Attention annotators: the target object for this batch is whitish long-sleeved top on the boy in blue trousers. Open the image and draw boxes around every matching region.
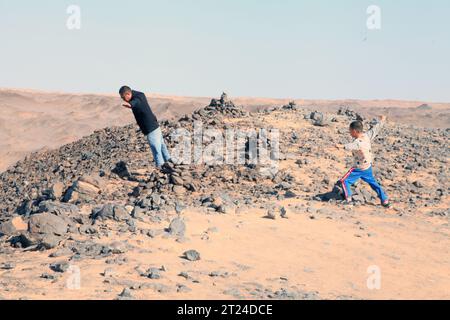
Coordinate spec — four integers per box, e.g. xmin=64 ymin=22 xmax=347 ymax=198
xmin=344 ymin=121 xmax=384 ymax=170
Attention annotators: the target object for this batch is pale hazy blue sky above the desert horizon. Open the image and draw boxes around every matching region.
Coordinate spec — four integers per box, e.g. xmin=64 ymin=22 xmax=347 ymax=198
xmin=0 ymin=0 xmax=450 ymax=102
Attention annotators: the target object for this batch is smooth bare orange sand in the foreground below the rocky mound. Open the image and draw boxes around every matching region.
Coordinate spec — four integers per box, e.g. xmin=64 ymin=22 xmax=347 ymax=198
xmin=0 ymin=203 xmax=450 ymax=299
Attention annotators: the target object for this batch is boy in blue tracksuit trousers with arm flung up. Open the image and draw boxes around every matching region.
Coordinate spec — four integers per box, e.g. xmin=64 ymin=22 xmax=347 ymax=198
xmin=338 ymin=116 xmax=391 ymax=208
